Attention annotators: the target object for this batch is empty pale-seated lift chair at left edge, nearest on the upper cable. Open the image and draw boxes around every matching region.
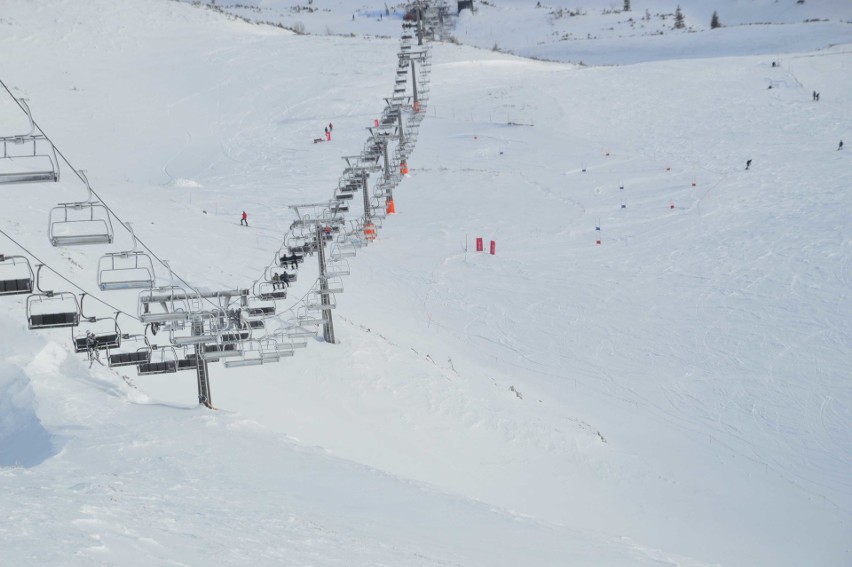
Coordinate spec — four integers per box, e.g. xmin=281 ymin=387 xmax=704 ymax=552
xmin=0 ymin=99 xmax=59 ymax=184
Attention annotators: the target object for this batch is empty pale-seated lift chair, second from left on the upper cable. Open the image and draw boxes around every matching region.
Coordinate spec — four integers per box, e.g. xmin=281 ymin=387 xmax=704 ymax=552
xmin=48 ymin=171 xmax=113 ymax=246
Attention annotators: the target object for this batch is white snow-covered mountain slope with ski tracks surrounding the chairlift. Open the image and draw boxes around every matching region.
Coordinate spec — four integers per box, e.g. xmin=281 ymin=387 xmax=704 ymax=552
xmin=0 ymin=0 xmax=852 ymax=566
